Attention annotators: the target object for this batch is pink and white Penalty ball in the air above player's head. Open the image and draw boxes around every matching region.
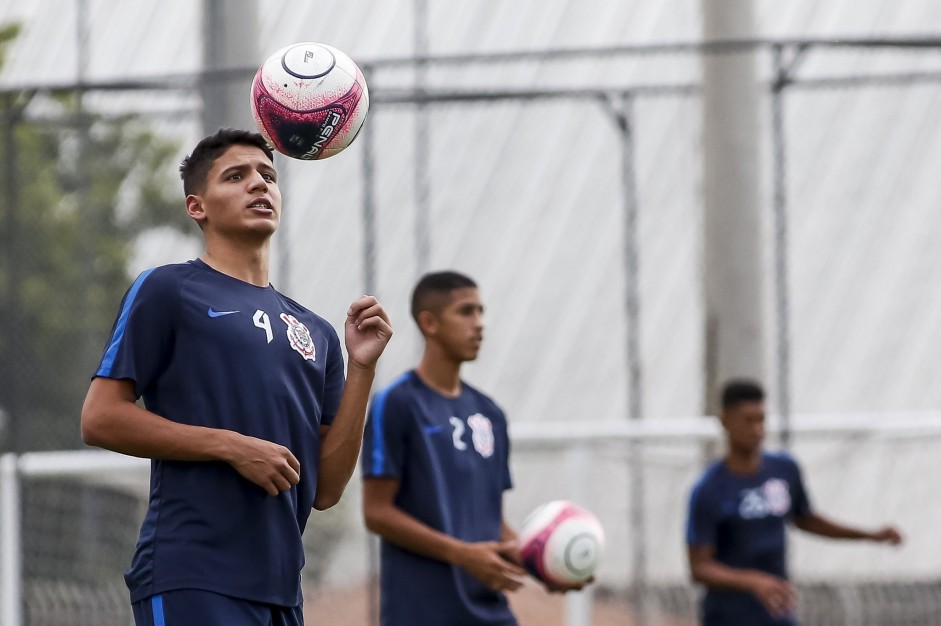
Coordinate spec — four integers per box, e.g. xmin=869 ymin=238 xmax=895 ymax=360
xmin=252 ymin=42 xmax=369 ymax=160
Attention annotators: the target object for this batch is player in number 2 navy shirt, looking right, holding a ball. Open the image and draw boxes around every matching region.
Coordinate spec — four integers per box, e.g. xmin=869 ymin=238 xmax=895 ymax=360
xmin=362 ymin=272 xmax=525 ymax=626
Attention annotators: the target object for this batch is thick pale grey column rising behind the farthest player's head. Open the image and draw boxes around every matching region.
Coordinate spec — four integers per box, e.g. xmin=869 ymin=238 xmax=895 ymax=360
xmin=700 ymin=0 xmax=765 ymax=420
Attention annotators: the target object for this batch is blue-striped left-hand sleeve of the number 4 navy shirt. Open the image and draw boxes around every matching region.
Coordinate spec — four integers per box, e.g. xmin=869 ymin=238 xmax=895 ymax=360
xmin=95 ymin=269 xmax=179 ymax=396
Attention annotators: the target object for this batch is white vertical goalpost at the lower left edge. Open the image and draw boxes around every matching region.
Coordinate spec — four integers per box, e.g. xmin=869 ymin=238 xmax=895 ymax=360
xmin=0 ymin=452 xmax=23 ymax=626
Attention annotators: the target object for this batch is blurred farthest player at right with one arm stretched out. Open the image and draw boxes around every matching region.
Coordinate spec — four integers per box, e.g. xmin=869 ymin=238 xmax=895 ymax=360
xmin=686 ymin=380 xmax=902 ymax=626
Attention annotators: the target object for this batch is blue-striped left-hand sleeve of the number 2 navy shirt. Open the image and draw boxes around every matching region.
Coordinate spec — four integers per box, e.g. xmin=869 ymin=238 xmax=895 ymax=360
xmin=360 ymin=387 xmax=408 ymax=478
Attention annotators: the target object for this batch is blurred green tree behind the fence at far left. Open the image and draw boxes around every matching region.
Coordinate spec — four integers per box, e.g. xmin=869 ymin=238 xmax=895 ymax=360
xmin=0 ymin=26 xmax=192 ymax=450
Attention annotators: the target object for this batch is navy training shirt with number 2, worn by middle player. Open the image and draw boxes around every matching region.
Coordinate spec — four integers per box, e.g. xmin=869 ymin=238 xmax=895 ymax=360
xmin=361 ymin=371 xmax=516 ymax=626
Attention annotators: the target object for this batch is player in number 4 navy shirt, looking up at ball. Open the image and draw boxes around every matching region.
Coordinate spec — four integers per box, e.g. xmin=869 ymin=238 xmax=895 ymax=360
xmin=82 ymin=129 xmax=392 ymax=626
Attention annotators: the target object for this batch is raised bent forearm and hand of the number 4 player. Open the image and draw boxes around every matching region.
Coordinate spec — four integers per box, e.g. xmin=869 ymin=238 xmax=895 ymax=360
xmin=314 ymin=296 xmax=392 ymax=511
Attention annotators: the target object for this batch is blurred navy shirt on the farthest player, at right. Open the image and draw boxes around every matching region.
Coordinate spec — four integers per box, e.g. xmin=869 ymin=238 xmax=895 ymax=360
xmin=686 ymin=452 xmax=811 ymax=626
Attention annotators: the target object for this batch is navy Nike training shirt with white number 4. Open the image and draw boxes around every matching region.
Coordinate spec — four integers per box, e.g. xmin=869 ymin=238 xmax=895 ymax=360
xmin=96 ymin=260 xmax=344 ymax=606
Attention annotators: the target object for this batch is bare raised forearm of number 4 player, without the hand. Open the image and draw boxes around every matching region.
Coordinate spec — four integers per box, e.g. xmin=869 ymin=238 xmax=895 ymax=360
xmin=314 ymin=361 xmax=376 ymax=511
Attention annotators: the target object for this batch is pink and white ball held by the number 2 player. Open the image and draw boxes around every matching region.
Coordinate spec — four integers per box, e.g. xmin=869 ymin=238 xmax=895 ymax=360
xmin=519 ymin=500 xmax=604 ymax=585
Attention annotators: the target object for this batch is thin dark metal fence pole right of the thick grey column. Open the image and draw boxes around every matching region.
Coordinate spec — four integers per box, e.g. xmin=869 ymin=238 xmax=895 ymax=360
xmin=771 ymin=45 xmax=791 ymax=448
